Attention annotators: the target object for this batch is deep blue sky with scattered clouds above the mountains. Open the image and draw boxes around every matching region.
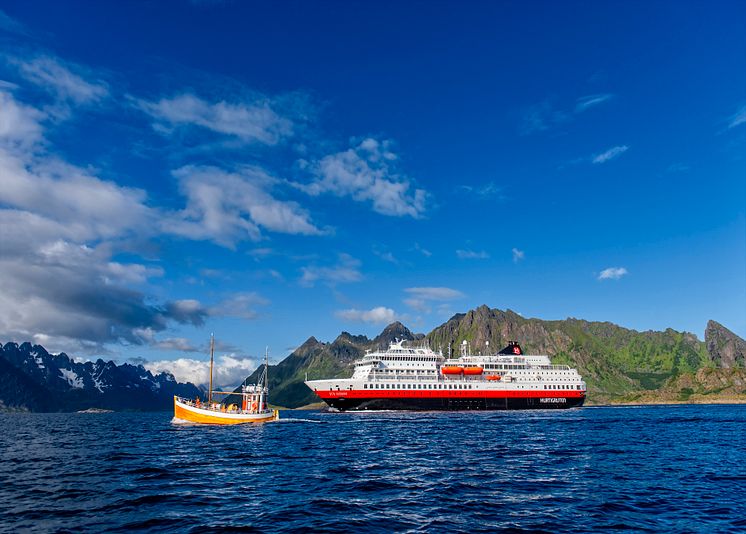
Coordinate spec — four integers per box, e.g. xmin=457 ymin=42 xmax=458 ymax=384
xmin=0 ymin=1 xmax=746 ymax=381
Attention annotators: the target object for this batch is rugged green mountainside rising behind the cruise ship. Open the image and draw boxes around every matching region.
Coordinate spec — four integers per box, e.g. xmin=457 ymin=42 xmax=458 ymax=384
xmin=235 ymin=306 xmax=746 ymax=408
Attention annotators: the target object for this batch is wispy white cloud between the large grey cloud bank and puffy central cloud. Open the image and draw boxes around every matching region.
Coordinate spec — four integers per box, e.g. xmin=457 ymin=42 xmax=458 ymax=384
xmin=162 ymin=166 xmax=323 ymax=247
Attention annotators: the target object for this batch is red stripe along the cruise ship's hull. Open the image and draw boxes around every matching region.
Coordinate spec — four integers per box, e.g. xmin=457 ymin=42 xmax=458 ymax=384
xmin=315 ymin=389 xmax=585 ymax=399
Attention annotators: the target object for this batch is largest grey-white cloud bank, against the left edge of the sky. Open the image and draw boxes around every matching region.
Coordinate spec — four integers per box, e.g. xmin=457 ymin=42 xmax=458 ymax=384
xmin=0 ymin=93 xmax=204 ymax=350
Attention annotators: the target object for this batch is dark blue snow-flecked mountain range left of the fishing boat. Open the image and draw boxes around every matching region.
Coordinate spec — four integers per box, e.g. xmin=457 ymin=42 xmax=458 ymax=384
xmin=0 ymin=343 xmax=201 ymax=412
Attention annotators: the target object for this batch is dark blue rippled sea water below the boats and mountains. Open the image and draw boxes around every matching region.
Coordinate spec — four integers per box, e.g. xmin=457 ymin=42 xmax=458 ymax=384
xmin=0 ymin=406 xmax=746 ymax=532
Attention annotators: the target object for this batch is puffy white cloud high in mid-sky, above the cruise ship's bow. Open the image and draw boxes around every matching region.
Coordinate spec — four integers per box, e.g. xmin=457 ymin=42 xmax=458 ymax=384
xmin=294 ymin=138 xmax=428 ymax=218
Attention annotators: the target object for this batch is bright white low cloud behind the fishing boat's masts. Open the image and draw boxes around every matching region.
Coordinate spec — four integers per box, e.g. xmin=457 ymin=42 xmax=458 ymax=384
xmin=144 ymin=354 xmax=256 ymax=390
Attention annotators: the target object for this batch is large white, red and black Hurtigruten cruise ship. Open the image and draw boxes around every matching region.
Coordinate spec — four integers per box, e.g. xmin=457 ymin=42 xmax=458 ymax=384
xmin=305 ymin=341 xmax=586 ymax=411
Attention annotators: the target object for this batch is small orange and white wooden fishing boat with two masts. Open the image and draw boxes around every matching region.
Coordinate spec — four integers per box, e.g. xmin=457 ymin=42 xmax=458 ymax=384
xmin=174 ymin=336 xmax=280 ymax=425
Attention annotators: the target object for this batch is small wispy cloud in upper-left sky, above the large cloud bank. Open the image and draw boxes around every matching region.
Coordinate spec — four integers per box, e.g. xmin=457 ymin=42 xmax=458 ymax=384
xmin=11 ymin=56 xmax=109 ymax=104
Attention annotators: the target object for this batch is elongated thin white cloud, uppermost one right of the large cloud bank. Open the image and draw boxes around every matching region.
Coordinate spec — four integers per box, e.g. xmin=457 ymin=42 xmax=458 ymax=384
xmin=136 ymin=93 xmax=293 ymax=145
